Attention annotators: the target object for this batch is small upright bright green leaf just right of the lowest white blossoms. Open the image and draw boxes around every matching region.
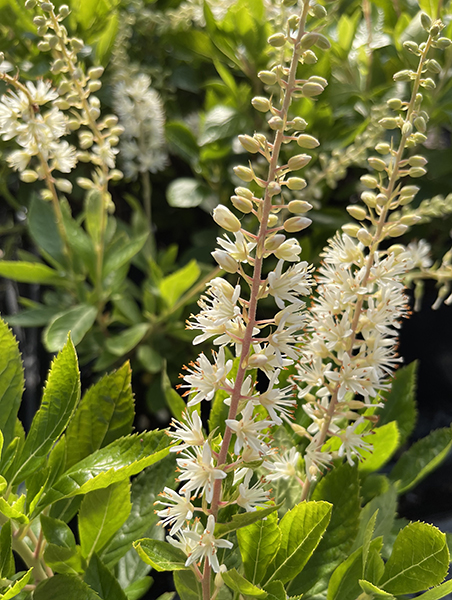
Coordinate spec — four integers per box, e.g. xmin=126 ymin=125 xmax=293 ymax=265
xmin=237 ymin=512 xmax=281 ymax=583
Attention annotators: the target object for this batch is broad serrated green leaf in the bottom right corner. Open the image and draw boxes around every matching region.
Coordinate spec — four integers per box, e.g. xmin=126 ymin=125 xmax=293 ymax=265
xmin=379 ymin=523 xmax=449 ymax=594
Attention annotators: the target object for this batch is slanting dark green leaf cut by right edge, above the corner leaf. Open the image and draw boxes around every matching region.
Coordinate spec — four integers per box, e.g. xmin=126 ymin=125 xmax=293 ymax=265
xmin=389 ymin=428 xmax=452 ymax=494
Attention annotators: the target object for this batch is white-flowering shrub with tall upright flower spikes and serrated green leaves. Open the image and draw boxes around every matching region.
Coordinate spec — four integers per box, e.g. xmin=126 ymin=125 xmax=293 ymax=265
xmin=0 ymin=0 xmax=452 ymax=600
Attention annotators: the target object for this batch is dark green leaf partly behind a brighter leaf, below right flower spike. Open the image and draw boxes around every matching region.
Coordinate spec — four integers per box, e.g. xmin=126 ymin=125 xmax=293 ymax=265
xmin=292 ymin=463 xmax=361 ymax=600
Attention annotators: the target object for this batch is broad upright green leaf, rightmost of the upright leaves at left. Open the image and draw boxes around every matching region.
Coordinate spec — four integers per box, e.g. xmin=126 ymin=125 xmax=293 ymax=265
xmin=66 ymin=362 xmax=135 ymax=468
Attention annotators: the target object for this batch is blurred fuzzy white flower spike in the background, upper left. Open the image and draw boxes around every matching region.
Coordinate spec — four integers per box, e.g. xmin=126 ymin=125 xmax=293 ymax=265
xmin=113 ymin=72 xmax=168 ymax=179
